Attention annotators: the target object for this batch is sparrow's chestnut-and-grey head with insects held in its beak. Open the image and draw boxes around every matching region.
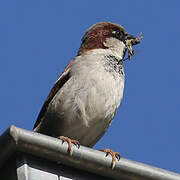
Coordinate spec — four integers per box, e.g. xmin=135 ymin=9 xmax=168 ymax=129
xmin=78 ymin=22 xmax=142 ymax=60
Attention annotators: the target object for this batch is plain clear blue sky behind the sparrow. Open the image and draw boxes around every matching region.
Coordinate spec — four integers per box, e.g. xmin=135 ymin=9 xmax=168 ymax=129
xmin=0 ymin=0 xmax=180 ymax=172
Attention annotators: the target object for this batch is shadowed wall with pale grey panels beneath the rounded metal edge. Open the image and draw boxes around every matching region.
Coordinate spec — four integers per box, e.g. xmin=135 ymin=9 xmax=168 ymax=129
xmin=17 ymin=154 xmax=109 ymax=180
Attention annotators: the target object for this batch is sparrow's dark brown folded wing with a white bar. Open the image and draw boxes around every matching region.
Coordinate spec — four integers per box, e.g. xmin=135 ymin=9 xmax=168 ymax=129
xmin=33 ymin=59 xmax=74 ymax=129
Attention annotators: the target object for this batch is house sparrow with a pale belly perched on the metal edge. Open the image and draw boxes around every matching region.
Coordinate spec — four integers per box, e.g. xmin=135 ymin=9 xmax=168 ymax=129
xmin=34 ymin=22 xmax=141 ymax=168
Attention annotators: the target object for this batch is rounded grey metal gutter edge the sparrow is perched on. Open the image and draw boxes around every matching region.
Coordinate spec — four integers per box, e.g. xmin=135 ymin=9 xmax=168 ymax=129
xmin=0 ymin=126 xmax=180 ymax=180
